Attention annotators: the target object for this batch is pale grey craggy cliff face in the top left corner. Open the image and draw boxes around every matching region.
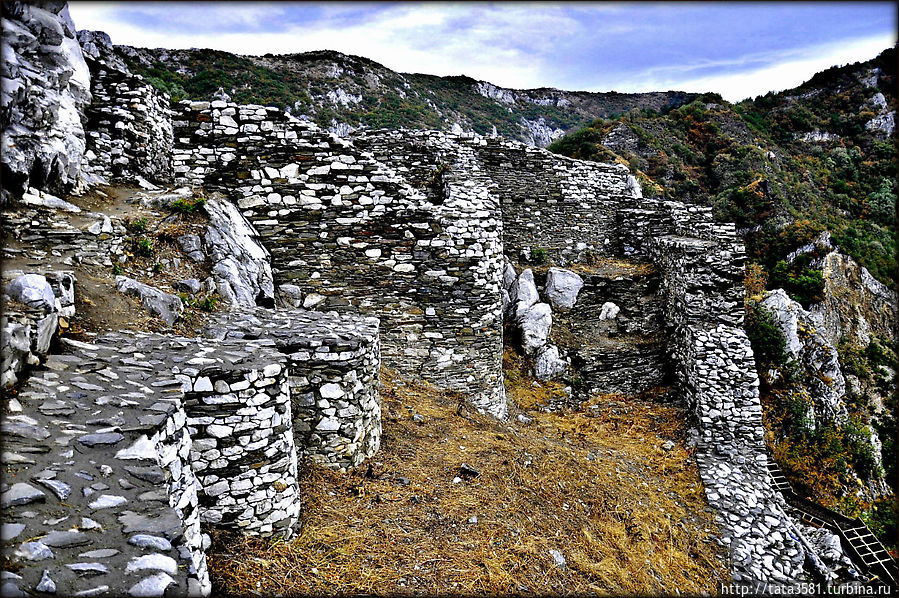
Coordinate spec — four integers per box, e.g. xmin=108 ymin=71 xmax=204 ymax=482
xmin=0 ymin=1 xmax=91 ymax=203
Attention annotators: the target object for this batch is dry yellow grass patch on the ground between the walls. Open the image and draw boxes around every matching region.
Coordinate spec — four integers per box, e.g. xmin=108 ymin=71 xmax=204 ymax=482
xmin=209 ymin=372 xmax=725 ymax=595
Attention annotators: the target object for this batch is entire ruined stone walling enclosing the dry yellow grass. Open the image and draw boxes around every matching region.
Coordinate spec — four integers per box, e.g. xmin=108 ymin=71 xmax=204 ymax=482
xmin=2 ymin=61 xmax=868 ymax=595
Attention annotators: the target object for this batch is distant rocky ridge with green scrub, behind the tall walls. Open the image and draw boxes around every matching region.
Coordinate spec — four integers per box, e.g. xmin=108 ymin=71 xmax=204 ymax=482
xmin=105 ymin=46 xmax=696 ymax=146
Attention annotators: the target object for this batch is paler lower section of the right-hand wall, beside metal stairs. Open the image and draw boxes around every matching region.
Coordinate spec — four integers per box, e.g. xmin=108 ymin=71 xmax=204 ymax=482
xmin=676 ymin=325 xmax=806 ymax=585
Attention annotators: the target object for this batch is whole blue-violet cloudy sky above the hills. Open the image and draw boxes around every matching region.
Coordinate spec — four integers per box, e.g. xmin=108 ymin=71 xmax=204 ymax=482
xmin=70 ymin=1 xmax=897 ymax=101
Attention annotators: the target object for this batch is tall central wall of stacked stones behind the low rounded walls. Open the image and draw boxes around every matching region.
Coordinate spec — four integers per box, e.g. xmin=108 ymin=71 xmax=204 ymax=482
xmin=174 ymin=101 xmax=506 ymax=417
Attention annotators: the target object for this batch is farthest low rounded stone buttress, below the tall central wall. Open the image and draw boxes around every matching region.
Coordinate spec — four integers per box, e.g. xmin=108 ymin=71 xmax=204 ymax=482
xmin=205 ymin=309 xmax=381 ymax=470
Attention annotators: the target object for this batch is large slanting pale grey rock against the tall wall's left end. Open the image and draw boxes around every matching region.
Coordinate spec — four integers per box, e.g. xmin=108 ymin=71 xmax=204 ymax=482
xmin=205 ymin=198 xmax=275 ymax=309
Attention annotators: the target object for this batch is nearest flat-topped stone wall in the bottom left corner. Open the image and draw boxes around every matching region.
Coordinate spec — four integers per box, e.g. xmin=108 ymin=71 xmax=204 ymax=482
xmin=0 ymin=339 xmax=210 ymax=596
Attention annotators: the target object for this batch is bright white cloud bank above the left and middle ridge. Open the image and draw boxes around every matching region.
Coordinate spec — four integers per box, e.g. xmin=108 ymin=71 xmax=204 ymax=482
xmin=71 ymin=2 xmax=552 ymax=87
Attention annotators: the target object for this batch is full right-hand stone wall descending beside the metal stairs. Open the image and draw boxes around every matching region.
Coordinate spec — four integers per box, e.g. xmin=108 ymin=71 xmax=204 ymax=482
xmin=644 ymin=202 xmax=808 ymax=587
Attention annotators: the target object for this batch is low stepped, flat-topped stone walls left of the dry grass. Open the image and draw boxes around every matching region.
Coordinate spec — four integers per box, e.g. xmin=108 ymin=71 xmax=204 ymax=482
xmin=2 ymin=309 xmax=380 ymax=596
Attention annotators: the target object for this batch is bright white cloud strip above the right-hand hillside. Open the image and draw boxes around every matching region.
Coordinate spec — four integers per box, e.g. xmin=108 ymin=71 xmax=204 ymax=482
xmin=608 ymin=34 xmax=896 ymax=102
